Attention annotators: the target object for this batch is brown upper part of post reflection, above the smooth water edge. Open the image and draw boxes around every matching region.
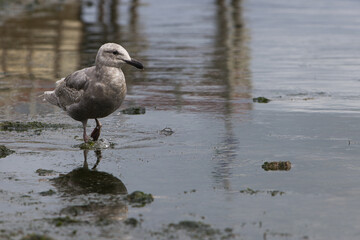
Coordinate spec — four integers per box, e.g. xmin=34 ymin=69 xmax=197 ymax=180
xmin=208 ymin=0 xmax=252 ymax=114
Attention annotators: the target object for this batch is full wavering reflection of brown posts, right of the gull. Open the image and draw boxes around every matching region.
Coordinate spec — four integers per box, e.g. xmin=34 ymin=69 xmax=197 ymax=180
xmin=212 ymin=0 xmax=252 ymax=190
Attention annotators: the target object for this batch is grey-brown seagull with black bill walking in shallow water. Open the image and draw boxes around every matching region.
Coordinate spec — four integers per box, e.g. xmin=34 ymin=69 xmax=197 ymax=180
xmin=44 ymin=43 xmax=144 ymax=142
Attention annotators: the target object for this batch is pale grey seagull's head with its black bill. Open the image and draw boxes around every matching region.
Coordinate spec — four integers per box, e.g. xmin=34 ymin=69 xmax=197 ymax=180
xmin=96 ymin=43 xmax=144 ymax=69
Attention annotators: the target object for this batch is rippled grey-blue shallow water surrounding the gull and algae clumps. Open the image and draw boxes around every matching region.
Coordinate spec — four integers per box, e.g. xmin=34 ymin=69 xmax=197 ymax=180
xmin=0 ymin=0 xmax=360 ymax=239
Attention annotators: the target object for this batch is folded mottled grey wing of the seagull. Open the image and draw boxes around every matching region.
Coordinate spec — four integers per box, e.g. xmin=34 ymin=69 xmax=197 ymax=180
xmin=44 ymin=67 xmax=95 ymax=111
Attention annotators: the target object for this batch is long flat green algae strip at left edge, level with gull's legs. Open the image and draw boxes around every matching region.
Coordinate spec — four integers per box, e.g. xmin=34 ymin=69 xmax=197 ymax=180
xmin=0 ymin=121 xmax=71 ymax=132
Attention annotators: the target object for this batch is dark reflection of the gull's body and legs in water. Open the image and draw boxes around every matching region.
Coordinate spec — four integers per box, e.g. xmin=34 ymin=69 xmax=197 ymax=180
xmin=52 ymin=150 xmax=128 ymax=222
